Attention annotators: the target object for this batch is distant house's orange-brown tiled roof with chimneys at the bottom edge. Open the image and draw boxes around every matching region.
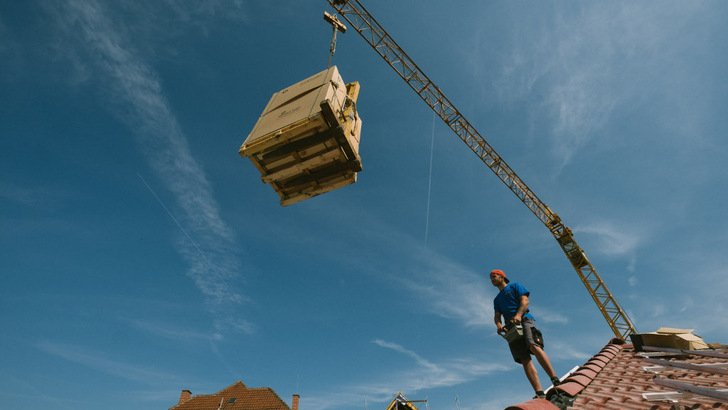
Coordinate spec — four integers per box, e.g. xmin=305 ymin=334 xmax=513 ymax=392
xmin=169 ymin=381 xmax=299 ymax=410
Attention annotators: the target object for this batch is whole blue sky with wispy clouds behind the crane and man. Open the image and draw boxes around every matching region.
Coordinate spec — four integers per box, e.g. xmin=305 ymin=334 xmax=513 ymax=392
xmin=0 ymin=0 xmax=728 ymax=409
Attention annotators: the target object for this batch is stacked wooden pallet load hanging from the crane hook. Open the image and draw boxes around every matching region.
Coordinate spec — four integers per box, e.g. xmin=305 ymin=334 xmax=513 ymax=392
xmin=238 ymin=66 xmax=362 ymax=206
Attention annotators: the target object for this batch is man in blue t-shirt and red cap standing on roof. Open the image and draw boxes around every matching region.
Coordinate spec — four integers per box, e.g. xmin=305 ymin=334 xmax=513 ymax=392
xmin=490 ymin=269 xmax=559 ymax=398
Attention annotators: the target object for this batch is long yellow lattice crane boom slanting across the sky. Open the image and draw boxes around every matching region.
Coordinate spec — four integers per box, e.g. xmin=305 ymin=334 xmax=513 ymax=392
xmin=328 ymin=0 xmax=637 ymax=340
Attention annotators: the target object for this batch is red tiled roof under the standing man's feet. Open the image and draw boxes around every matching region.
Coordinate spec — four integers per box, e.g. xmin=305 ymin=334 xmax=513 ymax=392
xmin=508 ymin=339 xmax=728 ymax=410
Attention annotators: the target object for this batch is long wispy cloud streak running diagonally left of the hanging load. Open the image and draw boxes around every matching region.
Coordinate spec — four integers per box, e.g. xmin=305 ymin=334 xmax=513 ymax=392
xmin=48 ymin=1 xmax=253 ymax=335
